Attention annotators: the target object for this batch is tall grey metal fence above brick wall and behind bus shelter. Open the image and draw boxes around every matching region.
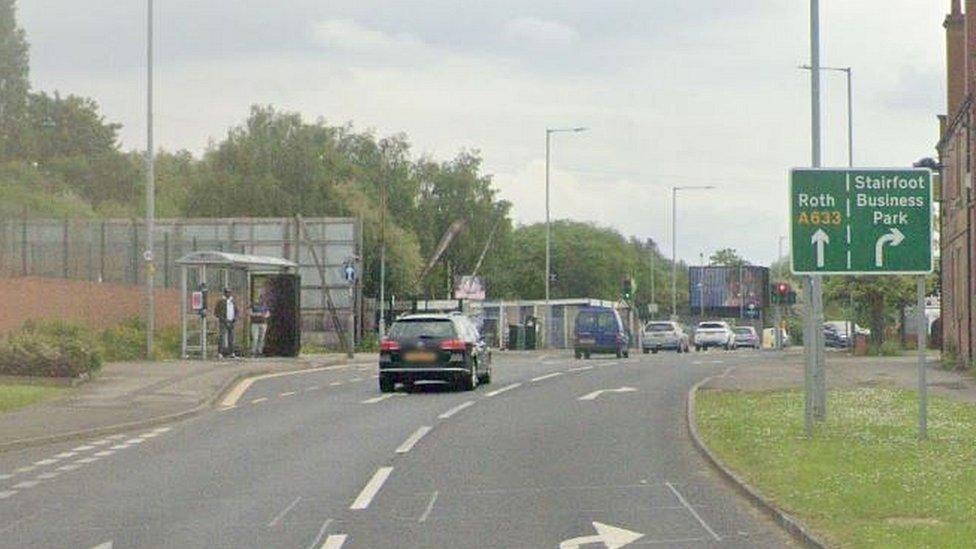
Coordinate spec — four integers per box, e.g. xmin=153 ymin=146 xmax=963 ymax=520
xmin=0 ymin=218 xmax=362 ymax=343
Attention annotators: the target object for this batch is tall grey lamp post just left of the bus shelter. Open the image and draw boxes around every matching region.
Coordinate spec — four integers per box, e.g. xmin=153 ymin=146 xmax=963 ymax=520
xmin=143 ymin=0 xmax=155 ymax=358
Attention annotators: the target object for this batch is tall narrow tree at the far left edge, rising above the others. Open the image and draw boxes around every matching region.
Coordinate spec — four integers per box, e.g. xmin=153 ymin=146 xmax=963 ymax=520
xmin=0 ymin=0 xmax=30 ymax=161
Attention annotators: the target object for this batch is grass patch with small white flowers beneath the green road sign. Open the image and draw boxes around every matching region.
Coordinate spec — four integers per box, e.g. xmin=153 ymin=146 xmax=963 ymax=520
xmin=697 ymin=388 xmax=976 ymax=548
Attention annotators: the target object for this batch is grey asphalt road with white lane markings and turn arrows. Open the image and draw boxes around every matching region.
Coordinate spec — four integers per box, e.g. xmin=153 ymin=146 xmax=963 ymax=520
xmin=0 ymin=351 xmax=791 ymax=549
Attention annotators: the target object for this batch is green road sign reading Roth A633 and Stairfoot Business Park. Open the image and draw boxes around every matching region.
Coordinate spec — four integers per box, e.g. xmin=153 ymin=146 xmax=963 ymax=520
xmin=790 ymin=169 xmax=932 ymax=274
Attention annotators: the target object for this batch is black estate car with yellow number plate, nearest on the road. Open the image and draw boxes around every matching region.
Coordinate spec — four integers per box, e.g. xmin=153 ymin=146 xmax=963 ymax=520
xmin=379 ymin=313 xmax=491 ymax=393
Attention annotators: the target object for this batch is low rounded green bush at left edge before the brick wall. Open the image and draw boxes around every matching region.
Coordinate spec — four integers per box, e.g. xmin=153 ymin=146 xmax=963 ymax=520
xmin=0 ymin=322 xmax=102 ymax=377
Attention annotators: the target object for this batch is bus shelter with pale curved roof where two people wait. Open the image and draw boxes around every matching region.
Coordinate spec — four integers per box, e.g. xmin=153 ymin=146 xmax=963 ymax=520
xmin=176 ymin=251 xmax=301 ymax=358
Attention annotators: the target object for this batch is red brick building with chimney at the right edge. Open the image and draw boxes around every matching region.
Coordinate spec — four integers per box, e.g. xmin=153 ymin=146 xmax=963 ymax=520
xmin=937 ymin=0 xmax=976 ymax=364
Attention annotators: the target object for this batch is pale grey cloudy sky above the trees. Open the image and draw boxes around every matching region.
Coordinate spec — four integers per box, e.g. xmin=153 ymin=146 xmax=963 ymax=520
xmin=19 ymin=0 xmax=949 ymax=263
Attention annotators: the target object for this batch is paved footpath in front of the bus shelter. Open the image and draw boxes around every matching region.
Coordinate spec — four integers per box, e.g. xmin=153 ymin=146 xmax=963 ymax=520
xmin=0 ymin=353 xmax=376 ymax=451
